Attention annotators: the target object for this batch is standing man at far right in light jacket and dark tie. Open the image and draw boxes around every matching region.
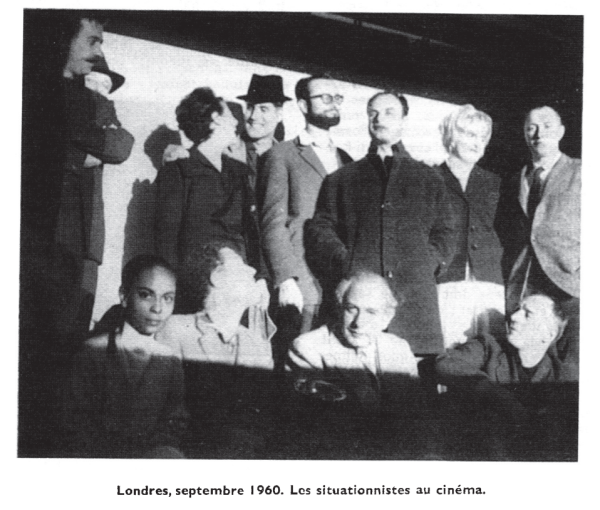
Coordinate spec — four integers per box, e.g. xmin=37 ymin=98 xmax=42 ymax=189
xmin=506 ymin=106 xmax=581 ymax=315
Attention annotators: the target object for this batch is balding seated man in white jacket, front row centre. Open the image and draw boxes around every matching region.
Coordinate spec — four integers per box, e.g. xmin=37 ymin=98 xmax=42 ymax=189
xmin=288 ymin=273 xmax=418 ymax=412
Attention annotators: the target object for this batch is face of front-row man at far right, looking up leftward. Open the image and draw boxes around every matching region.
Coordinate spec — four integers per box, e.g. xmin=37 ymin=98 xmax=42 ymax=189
xmin=508 ymin=295 xmax=561 ymax=350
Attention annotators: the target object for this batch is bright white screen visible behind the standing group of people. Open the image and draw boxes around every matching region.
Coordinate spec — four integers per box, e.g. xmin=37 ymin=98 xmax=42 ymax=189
xmin=93 ymin=33 xmax=455 ymax=321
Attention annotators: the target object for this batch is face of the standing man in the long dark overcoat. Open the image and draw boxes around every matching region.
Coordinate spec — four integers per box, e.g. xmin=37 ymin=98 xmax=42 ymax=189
xmin=367 ymin=94 xmax=404 ymax=145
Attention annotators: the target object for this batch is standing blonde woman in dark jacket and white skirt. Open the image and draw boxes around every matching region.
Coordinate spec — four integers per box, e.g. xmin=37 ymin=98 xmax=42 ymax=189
xmin=438 ymin=105 xmax=504 ymax=347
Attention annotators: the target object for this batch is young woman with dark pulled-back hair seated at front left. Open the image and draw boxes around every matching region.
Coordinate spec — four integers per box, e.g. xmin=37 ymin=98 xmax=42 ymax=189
xmin=65 ymin=255 xmax=187 ymax=458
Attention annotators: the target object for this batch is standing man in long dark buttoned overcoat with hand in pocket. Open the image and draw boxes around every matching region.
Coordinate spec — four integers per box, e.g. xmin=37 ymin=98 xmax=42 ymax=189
xmin=305 ymin=92 xmax=456 ymax=355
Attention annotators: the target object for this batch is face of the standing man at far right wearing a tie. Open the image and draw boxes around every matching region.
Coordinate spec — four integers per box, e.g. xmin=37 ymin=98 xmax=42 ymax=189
xmin=524 ymin=106 xmax=565 ymax=161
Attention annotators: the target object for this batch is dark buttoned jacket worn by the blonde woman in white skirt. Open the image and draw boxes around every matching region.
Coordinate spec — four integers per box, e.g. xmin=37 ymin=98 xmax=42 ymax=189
xmin=437 ymin=163 xmax=504 ymax=285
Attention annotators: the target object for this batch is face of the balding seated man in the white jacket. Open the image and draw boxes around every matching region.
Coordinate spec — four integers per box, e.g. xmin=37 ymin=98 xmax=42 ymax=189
xmin=342 ymin=280 xmax=394 ymax=347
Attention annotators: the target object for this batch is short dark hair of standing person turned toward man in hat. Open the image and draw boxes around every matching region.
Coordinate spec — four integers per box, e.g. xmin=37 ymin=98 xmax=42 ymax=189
xmin=175 ymin=87 xmax=223 ymax=144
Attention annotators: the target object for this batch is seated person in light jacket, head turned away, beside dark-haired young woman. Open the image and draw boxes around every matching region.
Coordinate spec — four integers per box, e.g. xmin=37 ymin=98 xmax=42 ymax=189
xmin=157 ymin=242 xmax=274 ymax=458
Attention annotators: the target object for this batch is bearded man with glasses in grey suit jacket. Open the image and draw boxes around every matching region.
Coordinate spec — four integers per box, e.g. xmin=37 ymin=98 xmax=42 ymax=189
xmin=257 ymin=76 xmax=352 ymax=346
